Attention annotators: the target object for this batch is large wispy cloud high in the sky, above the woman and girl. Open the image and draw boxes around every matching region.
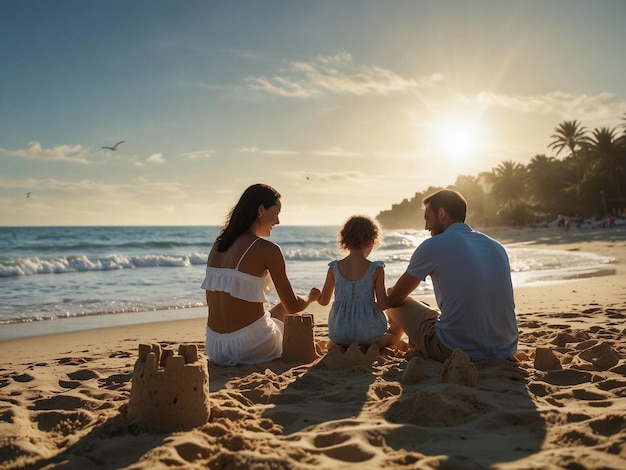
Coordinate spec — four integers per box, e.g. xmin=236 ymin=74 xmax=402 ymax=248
xmin=246 ymin=53 xmax=443 ymax=98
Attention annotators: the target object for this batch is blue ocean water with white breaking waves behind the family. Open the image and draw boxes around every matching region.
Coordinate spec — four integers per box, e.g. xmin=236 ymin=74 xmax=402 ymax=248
xmin=0 ymin=226 xmax=614 ymax=330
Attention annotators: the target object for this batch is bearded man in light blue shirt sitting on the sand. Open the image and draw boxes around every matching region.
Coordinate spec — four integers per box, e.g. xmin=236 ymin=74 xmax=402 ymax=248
xmin=386 ymin=189 xmax=519 ymax=362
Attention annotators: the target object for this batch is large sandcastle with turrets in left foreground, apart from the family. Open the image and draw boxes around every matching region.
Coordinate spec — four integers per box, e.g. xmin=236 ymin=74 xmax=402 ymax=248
xmin=128 ymin=343 xmax=210 ymax=431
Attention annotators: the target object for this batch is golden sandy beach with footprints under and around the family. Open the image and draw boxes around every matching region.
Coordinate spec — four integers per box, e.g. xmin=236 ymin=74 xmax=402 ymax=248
xmin=0 ymin=228 xmax=626 ymax=469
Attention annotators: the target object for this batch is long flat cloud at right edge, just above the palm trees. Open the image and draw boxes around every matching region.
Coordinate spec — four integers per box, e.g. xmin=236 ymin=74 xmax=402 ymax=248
xmin=467 ymin=91 xmax=626 ymax=119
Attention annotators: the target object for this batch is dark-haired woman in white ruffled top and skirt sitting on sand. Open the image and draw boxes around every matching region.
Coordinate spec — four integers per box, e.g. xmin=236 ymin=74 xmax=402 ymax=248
xmin=202 ymin=184 xmax=320 ymax=366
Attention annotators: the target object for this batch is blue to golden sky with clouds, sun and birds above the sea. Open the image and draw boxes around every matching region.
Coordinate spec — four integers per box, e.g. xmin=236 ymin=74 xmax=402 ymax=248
xmin=0 ymin=0 xmax=626 ymax=226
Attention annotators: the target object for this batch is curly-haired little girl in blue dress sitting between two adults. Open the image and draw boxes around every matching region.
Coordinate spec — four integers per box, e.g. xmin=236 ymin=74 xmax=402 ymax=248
xmin=318 ymin=216 xmax=395 ymax=349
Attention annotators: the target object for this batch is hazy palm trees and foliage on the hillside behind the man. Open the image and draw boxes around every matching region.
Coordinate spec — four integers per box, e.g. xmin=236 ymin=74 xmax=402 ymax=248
xmin=377 ymin=113 xmax=626 ymax=228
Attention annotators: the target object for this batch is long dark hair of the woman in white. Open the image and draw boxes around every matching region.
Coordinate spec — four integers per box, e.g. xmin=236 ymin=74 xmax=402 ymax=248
xmin=215 ymin=183 xmax=280 ymax=251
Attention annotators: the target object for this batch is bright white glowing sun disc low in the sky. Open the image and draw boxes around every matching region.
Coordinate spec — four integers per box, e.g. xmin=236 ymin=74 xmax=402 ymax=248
xmin=433 ymin=115 xmax=484 ymax=164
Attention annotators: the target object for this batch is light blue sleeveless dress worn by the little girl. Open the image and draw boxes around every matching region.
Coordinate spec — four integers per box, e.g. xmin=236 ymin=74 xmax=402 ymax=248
xmin=328 ymin=260 xmax=389 ymax=346
